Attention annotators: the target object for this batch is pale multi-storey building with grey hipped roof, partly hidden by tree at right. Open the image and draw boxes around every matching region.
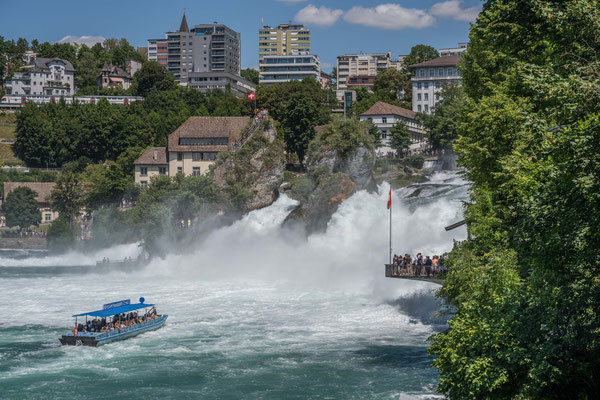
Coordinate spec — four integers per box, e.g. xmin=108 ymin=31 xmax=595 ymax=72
xmin=409 ymin=56 xmax=462 ymax=114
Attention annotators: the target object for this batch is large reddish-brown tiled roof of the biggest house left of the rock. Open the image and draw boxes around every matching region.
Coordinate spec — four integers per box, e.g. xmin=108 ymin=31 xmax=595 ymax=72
xmin=168 ymin=117 xmax=252 ymax=152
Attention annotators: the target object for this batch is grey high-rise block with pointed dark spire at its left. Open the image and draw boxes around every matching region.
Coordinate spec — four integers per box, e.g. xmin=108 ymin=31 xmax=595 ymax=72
xmin=167 ymin=15 xmax=241 ymax=85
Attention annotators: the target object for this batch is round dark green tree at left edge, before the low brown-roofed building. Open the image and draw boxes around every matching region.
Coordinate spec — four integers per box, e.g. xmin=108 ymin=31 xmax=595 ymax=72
xmin=2 ymin=186 xmax=42 ymax=229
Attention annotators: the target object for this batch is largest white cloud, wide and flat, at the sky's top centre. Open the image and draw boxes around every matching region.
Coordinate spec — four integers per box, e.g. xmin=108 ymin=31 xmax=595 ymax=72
xmin=344 ymin=4 xmax=435 ymax=29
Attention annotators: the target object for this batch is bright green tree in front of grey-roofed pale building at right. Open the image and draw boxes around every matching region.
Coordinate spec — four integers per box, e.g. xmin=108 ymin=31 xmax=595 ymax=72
xmin=419 ymin=85 xmax=466 ymax=149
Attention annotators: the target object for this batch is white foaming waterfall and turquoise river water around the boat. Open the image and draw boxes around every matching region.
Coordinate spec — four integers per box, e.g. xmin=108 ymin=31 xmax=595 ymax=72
xmin=0 ymin=173 xmax=467 ymax=400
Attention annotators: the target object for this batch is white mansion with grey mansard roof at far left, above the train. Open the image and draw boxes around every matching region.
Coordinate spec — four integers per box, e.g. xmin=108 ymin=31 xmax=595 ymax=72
xmin=4 ymin=57 xmax=75 ymax=96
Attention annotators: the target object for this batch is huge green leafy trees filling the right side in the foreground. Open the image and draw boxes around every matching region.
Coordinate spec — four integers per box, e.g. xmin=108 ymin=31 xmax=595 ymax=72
xmin=430 ymin=0 xmax=600 ymax=399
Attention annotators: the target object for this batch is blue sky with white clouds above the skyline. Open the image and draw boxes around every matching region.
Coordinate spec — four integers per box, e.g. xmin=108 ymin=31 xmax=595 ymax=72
xmin=0 ymin=0 xmax=481 ymax=71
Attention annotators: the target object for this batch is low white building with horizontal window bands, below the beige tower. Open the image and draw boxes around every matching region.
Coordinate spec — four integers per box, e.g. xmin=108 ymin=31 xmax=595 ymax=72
xmin=259 ymin=52 xmax=321 ymax=86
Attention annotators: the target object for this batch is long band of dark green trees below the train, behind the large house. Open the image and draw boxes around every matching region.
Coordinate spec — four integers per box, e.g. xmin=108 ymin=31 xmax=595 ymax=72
xmin=14 ymin=88 xmax=253 ymax=168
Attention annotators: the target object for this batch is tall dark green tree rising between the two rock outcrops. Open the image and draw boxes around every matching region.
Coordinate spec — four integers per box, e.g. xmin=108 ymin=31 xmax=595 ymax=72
xmin=282 ymin=93 xmax=319 ymax=163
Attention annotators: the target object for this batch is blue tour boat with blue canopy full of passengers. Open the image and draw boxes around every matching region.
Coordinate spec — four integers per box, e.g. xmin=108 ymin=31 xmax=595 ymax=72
xmin=58 ymin=297 xmax=168 ymax=347
